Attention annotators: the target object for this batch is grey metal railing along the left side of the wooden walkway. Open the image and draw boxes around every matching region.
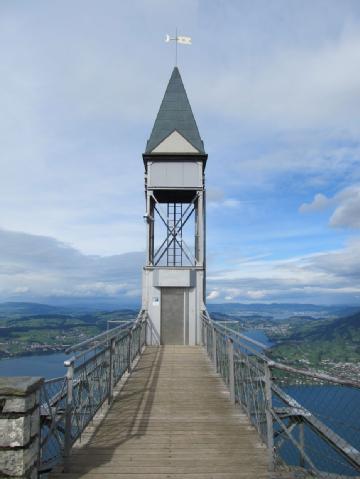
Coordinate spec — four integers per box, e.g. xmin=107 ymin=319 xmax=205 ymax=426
xmin=39 ymin=311 xmax=148 ymax=472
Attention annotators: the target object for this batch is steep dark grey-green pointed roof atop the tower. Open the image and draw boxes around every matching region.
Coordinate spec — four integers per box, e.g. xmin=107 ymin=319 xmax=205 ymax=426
xmin=145 ymin=67 xmax=205 ymax=154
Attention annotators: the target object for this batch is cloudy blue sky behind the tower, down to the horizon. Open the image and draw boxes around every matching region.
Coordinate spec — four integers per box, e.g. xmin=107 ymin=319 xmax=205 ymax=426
xmin=0 ymin=0 xmax=360 ymax=304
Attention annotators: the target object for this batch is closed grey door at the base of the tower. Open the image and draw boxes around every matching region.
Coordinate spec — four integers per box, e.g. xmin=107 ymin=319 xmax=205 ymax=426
xmin=161 ymin=288 xmax=185 ymax=344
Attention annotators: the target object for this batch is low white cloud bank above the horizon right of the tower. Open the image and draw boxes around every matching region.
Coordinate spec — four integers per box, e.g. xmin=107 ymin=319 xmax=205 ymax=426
xmin=208 ymin=238 xmax=360 ymax=304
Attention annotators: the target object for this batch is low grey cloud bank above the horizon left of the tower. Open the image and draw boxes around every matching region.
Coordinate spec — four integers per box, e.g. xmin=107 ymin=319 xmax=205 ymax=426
xmin=0 ymin=230 xmax=145 ymax=301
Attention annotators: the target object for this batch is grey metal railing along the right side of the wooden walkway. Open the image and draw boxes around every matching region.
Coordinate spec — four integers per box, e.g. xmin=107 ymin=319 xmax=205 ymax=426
xmin=201 ymin=311 xmax=360 ymax=478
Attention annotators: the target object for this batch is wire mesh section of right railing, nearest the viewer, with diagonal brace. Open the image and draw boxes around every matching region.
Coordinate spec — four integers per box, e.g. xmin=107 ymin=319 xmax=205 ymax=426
xmin=272 ymin=367 xmax=360 ymax=477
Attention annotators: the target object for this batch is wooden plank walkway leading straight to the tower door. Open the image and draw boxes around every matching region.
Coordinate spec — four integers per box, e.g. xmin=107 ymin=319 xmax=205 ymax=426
xmin=51 ymin=346 xmax=270 ymax=479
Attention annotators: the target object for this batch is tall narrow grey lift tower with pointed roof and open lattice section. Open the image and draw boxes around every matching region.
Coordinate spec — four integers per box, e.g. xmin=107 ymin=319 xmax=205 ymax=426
xmin=142 ymin=67 xmax=207 ymax=345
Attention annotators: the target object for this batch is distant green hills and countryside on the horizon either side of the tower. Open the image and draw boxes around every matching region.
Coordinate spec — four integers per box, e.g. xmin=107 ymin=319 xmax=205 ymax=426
xmin=0 ymin=301 xmax=360 ymax=364
